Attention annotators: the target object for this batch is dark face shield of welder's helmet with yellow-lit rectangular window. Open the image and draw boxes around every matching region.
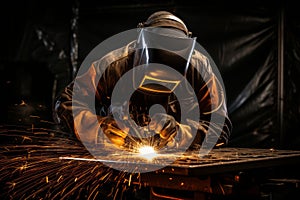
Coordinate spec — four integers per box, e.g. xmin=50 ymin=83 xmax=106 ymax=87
xmin=133 ymin=27 xmax=196 ymax=94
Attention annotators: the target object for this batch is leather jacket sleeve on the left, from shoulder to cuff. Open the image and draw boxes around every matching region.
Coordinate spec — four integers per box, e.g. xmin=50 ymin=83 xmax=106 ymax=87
xmin=54 ymin=49 xmax=134 ymax=144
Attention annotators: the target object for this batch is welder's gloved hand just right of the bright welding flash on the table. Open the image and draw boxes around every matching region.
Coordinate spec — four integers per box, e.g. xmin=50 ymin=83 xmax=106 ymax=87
xmin=148 ymin=113 xmax=179 ymax=149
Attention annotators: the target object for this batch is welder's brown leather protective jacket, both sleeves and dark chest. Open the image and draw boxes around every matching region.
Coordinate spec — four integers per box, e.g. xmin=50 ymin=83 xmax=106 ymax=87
xmin=54 ymin=41 xmax=232 ymax=150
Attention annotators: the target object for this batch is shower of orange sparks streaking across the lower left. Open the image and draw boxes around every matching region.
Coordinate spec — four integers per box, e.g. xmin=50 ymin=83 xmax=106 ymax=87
xmin=0 ymin=122 xmax=141 ymax=199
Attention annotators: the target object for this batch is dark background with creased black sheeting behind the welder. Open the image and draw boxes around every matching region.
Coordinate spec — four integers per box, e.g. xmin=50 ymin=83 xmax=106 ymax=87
xmin=0 ymin=0 xmax=300 ymax=149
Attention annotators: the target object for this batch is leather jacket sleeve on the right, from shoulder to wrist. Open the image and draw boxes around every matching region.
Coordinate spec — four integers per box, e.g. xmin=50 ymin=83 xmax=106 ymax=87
xmin=187 ymin=51 xmax=232 ymax=147
